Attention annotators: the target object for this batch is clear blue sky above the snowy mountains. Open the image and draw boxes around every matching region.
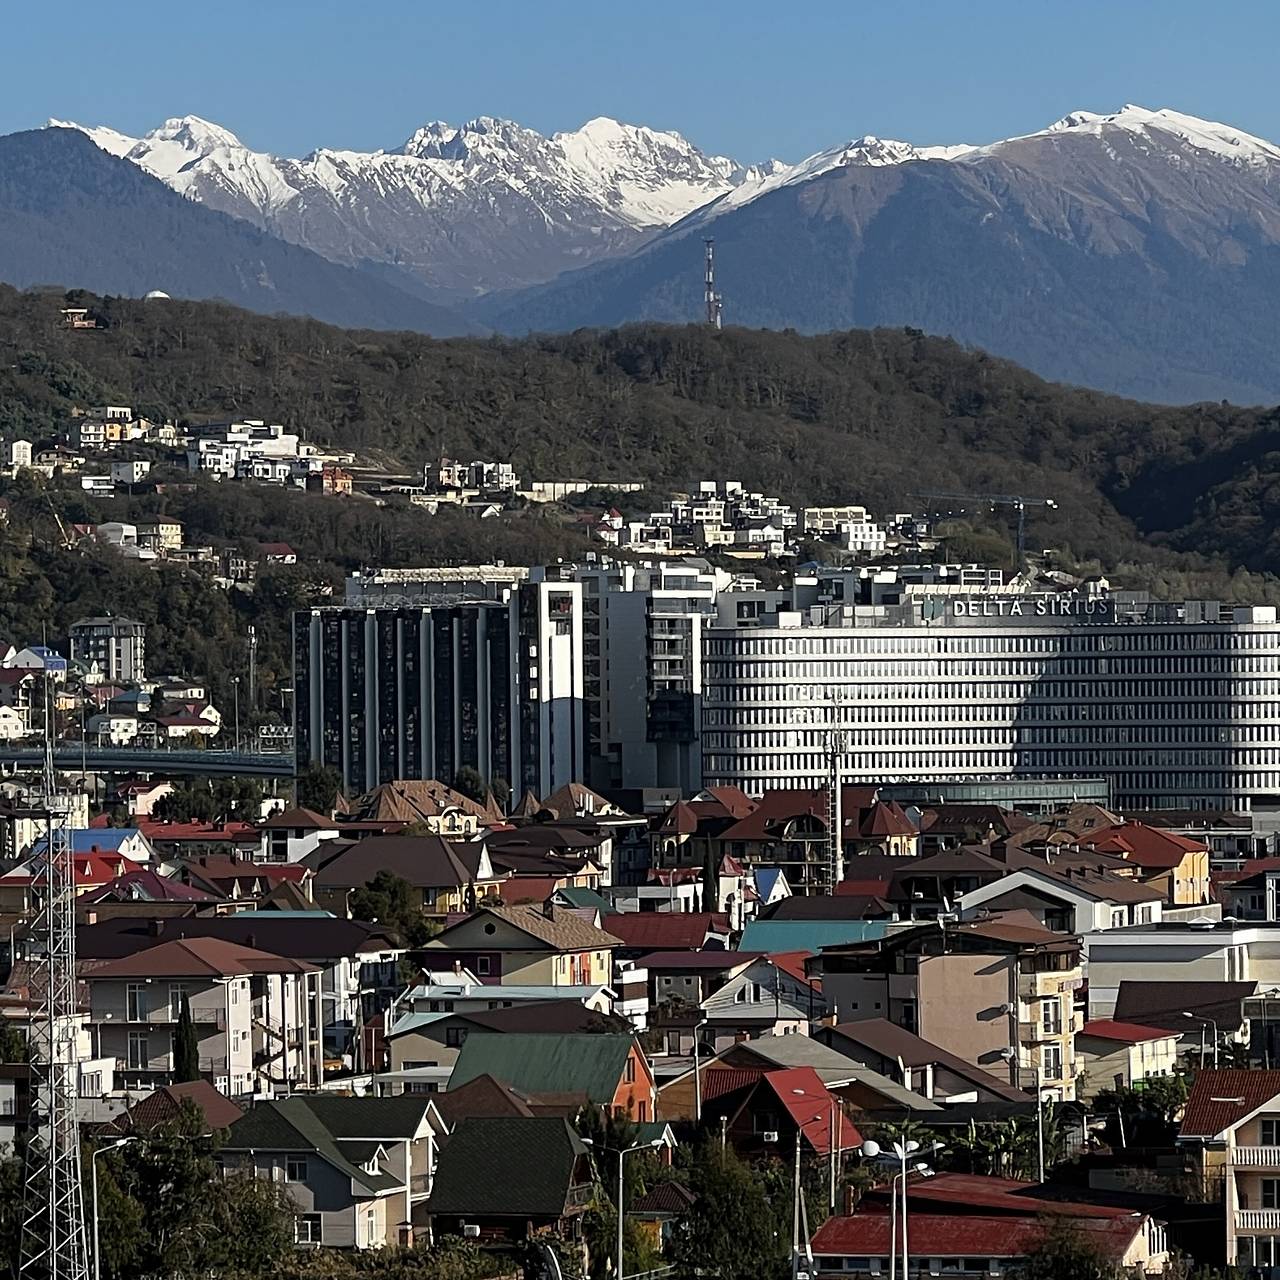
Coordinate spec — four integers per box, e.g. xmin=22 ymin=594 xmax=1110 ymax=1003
xmin=10 ymin=0 xmax=1280 ymax=161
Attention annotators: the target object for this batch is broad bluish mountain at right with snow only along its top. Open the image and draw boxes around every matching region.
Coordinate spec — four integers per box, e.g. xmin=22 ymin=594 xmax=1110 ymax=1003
xmin=474 ymin=105 xmax=1280 ymax=402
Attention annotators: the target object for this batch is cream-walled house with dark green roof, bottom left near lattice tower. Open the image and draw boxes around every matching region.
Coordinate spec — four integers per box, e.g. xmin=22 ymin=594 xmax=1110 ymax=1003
xmin=219 ymin=1094 xmax=445 ymax=1249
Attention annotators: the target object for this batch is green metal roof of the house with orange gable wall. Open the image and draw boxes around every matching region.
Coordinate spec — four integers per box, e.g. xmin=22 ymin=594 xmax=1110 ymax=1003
xmin=449 ymin=1032 xmax=634 ymax=1103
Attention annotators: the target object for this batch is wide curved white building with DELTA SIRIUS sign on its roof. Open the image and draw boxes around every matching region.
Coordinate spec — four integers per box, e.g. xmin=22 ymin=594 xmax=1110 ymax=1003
xmin=701 ymin=595 xmax=1280 ymax=810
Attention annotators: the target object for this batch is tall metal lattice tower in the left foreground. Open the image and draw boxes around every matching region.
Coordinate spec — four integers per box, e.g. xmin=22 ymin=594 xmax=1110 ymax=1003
xmin=18 ymin=672 xmax=90 ymax=1280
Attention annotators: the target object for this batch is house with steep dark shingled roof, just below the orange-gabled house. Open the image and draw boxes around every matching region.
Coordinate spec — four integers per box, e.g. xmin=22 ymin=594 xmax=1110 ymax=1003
xmin=428 ymin=1116 xmax=595 ymax=1242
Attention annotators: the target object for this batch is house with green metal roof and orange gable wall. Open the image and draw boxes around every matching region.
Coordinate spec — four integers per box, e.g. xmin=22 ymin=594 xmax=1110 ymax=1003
xmin=449 ymin=1032 xmax=657 ymax=1124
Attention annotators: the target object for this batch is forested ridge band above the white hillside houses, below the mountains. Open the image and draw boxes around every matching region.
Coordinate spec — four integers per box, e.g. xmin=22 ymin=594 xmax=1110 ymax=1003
xmin=0 ymin=288 xmax=1280 ymax=581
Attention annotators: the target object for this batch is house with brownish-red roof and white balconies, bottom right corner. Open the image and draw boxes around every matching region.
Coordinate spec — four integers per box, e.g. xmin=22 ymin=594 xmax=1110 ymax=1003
xmin=1178 ymin=1070 xmax=1280 ymax=1271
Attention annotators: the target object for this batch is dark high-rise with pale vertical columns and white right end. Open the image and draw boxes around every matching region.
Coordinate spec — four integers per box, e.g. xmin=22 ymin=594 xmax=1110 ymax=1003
xmin=293 ymin=582 xmax=585 ymax=796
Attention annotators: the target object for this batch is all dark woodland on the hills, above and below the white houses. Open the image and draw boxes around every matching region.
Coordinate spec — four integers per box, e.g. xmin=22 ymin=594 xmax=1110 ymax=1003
xmin=0 ymin=287 xmax=1280 ymax=703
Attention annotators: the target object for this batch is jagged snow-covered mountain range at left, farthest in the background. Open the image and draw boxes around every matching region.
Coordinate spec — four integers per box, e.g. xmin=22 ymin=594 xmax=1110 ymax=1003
xmin=50 ymin=115 xmax=772 ymax=296
